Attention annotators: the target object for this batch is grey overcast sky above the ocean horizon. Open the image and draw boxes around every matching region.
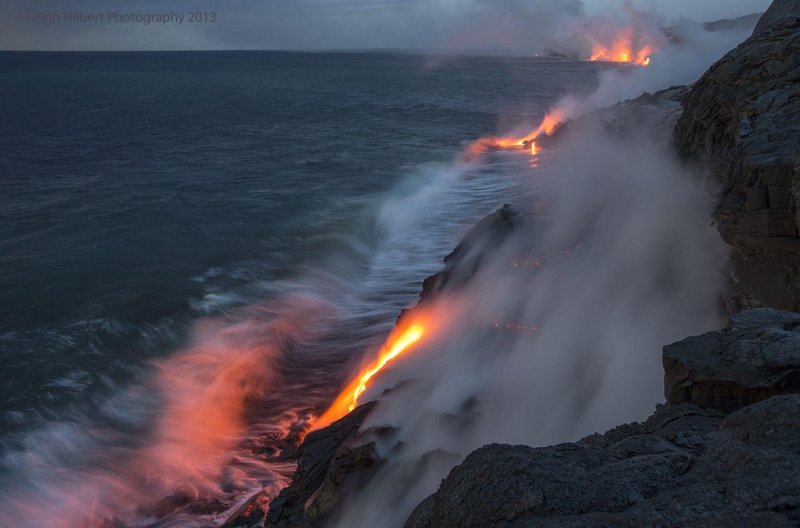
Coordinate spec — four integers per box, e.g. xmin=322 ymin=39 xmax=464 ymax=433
xmin=0 ymin=0 xmax=770 ymax=53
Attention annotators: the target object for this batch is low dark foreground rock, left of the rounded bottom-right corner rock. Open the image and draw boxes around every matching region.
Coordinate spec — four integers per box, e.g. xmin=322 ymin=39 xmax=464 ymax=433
xmin=405 ymin=405 xmax=723 ymax=528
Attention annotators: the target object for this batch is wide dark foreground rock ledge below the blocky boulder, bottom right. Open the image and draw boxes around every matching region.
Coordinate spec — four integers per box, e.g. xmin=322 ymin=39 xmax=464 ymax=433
xmin=405 ymin=394 xmax=800 ymax=528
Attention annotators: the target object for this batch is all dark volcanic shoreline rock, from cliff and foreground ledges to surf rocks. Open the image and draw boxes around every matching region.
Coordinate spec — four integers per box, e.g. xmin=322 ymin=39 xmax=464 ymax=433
xmin=225 ymin=0 xmax=800 ymax=528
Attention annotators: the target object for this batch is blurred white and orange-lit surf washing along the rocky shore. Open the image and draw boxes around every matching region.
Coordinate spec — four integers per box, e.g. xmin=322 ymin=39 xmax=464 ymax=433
xmin=0 ymin=157 xmax=521 ymax=527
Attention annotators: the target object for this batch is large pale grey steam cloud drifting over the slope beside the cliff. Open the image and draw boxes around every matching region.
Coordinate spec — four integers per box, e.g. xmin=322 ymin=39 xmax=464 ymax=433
xmin=326 ymin=9 xmax=746 ymax=528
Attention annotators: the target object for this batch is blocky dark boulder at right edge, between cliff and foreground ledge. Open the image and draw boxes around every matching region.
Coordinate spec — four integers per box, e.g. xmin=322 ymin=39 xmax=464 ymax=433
xmin=663 ymin=309 xmax=800 ymax=412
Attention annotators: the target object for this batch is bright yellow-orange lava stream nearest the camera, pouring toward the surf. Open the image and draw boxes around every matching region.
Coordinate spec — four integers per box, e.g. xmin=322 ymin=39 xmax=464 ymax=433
xmin=314 ymin=321 xmax=425 ymax=429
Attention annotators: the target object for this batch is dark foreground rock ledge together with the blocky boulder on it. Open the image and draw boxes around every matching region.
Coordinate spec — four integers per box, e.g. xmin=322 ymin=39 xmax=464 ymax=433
xmin=406 ymin=310 xmax=800 ymax=528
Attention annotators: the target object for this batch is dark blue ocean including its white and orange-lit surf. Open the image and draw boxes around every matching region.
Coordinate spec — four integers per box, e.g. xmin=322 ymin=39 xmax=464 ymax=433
xmin=0 ymin=52 xmax=603 ymax=526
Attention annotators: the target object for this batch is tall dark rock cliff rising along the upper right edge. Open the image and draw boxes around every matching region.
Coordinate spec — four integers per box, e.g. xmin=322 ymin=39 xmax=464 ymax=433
xmin=673 ymin=10 xmax=800 ymax=313
